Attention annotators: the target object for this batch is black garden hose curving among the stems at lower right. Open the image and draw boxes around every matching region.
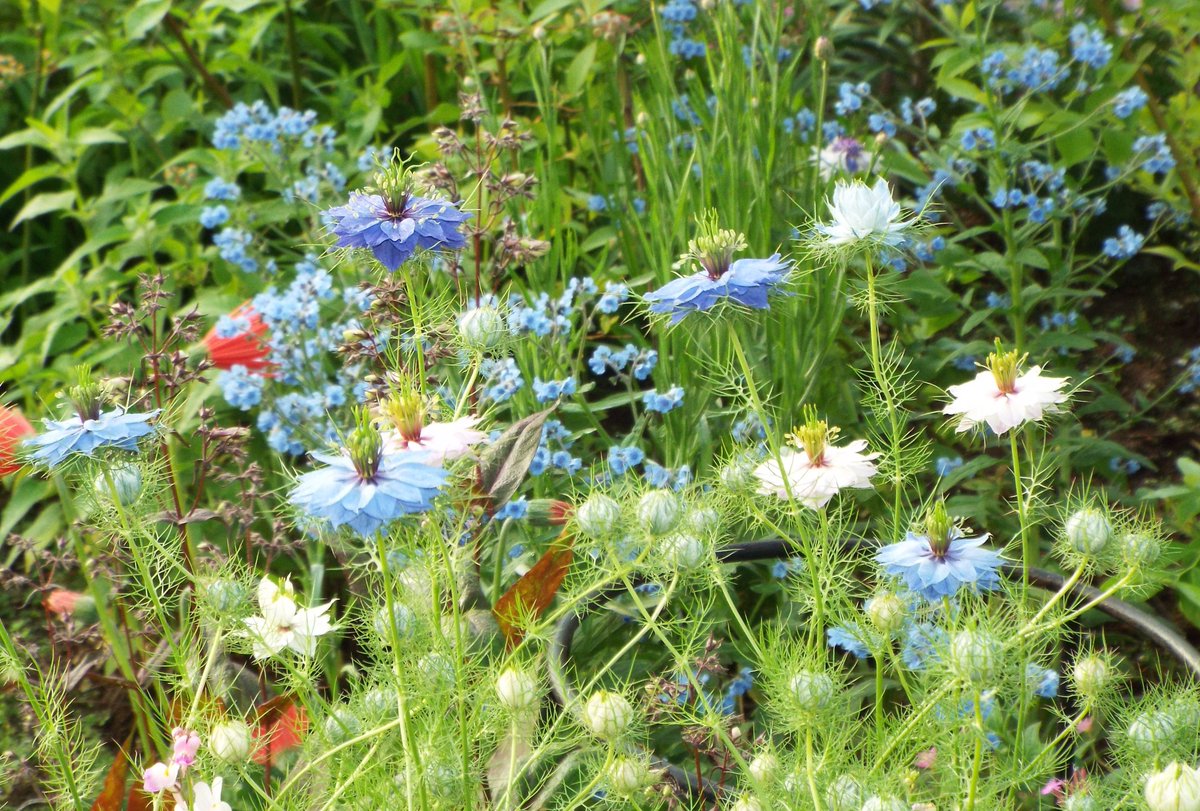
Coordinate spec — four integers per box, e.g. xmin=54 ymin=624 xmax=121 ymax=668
xmin=547 ymin=539 xmax=1200 ymax=799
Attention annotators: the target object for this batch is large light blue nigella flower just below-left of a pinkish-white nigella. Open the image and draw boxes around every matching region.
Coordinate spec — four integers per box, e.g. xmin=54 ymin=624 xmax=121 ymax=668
xmin=288 ymin=421 xmax=446 ymax=535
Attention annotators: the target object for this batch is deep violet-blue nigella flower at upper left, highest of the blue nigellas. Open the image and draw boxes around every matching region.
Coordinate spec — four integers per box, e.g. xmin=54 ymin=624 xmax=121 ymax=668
xmin=325 ymin=154 xmax=472 ymax=271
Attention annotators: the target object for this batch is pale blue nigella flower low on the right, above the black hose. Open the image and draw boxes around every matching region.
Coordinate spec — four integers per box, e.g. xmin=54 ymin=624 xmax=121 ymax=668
xmin=875 ymin=501 xmax=1003 ymax=602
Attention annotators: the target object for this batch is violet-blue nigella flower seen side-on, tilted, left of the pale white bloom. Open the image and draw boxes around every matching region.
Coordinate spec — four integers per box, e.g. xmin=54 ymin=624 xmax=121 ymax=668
xmin=644 ymin=212 xmax=791 ymax=324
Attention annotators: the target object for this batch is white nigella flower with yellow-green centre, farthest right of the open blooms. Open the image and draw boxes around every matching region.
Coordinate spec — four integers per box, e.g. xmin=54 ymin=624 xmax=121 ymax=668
xmin=942 ymin=342 xmax=1067 ymax=435
